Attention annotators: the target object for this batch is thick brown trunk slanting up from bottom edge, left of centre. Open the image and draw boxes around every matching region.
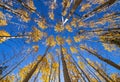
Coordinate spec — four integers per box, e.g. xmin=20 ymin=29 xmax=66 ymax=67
xmin=22 ymin=46 xmax=50 ymax=82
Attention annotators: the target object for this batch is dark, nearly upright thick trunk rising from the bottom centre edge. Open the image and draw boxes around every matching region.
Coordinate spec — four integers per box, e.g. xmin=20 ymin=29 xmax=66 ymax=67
xmin=61 ymin=46 xmax=71 ymax=82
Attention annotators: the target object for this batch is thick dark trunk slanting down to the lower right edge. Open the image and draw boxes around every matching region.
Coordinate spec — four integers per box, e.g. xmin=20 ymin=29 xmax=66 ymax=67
xmin=80 ymin=47 xmax=120 ymax=70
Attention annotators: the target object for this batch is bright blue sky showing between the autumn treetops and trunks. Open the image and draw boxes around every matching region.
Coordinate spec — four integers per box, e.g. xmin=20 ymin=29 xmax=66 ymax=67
xmin=0 ymin=0 xmax=120 ymax=81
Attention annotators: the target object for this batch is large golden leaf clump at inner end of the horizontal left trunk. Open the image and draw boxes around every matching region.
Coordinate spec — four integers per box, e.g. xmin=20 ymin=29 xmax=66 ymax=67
xmin=31 ymin=27 xmax=43 ymax=42
